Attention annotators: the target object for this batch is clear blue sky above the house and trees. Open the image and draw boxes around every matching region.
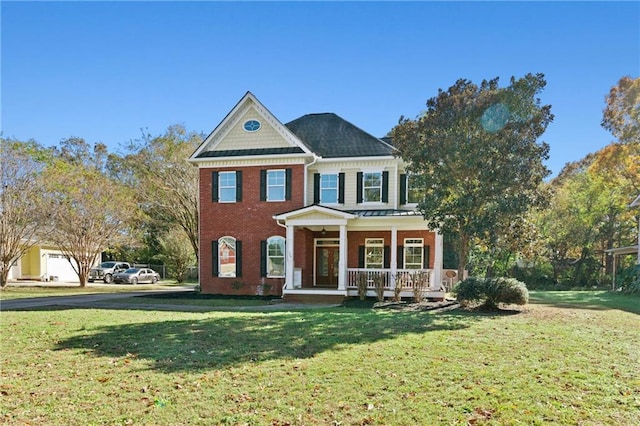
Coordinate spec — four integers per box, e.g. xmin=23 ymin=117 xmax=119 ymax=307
xmin=0 ymin=0 xmax=640 ymax=174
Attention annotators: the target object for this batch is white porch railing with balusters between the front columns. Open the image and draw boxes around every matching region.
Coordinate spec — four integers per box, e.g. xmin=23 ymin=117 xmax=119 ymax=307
xmin=347 ymin=268 xmax=439 ymax=291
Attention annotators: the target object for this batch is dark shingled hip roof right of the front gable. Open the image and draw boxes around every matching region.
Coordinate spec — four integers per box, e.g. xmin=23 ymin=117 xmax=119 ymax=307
xmin=285 ymin=113 xmax=394 ymax=158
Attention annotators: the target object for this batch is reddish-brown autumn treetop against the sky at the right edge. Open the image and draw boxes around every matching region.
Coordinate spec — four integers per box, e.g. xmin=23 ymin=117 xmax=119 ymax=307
xmin=602 ymin=76 xmax=640 ymax=143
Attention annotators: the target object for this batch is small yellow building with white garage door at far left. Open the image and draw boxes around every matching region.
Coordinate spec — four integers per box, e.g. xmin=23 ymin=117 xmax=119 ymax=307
xmin=9 ymin=244 xmax=87 ymax=282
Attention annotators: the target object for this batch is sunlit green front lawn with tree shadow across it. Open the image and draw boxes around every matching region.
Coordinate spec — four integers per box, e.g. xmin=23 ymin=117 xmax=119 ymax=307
xmin=0 ymin=292 xmax=640 ymax=425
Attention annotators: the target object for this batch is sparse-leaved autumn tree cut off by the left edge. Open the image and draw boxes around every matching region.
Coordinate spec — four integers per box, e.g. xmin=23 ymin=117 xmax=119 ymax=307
xmin=0 ymin=138 xmax=49 ymax=288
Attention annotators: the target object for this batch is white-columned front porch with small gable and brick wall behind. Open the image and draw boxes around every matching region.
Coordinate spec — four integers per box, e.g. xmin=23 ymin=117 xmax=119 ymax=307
xmin=274 ymin=205 xmax=446 ymax=301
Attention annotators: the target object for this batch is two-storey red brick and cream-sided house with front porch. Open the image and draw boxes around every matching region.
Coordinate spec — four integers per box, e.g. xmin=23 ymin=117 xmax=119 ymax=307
xmin=189 ymin=92 xmax=446 ymax=301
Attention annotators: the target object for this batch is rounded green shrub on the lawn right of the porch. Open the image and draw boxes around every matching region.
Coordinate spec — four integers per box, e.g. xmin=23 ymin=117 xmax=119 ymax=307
xmin=453 ymin=277 xmax=529 ymax=309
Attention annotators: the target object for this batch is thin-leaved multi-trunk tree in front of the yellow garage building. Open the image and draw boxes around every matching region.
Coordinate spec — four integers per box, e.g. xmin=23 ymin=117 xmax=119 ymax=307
xmin=44 ymin=138 xmax=137 ymax=287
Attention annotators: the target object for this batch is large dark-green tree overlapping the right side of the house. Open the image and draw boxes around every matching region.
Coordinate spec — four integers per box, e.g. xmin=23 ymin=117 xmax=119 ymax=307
xmin=391 ymin=74 xmax=553 ymax=276
